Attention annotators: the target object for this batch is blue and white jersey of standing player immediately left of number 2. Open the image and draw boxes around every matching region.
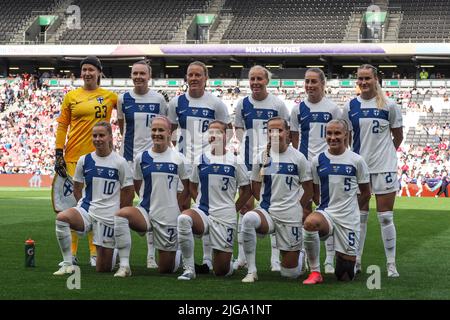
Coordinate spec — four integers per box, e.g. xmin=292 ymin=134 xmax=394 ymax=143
xmin=291 ymin=97 xmax=342 ymax=161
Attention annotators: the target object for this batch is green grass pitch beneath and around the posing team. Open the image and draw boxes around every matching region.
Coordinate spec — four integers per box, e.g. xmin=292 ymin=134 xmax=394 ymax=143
xmin=0 ymin=188 xmax=450 ymax=300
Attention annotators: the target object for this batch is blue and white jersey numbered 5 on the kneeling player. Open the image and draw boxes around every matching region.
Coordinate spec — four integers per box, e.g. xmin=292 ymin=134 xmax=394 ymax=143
xmin=312 ymin=149 xmax=370 ymax=230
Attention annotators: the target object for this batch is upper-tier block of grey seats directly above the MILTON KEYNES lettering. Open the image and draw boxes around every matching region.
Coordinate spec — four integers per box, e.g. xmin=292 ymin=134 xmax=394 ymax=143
xmin=222 ymin=0 xmax=371 ymax=42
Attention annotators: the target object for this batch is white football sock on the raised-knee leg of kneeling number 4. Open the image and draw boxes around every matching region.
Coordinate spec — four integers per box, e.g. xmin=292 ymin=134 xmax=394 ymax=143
xmin=242 ymin=211 xmax=261 ymax=273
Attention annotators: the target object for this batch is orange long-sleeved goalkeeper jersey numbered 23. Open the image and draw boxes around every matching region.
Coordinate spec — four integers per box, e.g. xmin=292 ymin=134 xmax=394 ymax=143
xmin=56 ymin=88 xmax=117 ymax=162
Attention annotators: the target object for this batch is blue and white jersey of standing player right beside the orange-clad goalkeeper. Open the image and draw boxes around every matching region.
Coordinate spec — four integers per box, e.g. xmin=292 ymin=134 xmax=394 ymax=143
xmin=117 ymin=90 xmax=167 ymax=161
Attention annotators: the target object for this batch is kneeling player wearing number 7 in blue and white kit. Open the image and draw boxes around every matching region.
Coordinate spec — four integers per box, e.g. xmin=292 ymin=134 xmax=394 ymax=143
xmin=114 ymin=115 xmax=189 ymax=277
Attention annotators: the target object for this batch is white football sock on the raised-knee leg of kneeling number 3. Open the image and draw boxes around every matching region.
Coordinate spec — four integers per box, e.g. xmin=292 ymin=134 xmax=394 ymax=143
xmin=177 ymin=214 xmax=195 ymax=271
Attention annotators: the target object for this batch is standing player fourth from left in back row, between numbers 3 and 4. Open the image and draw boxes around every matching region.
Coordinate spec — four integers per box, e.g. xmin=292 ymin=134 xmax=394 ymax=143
xmin=234 ymin=65 xmax=289 ymax=271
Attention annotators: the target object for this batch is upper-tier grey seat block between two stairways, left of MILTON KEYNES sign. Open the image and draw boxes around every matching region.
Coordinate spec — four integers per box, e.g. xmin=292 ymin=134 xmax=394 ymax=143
xmin=59 ymin=0 xmax=208 ymax=44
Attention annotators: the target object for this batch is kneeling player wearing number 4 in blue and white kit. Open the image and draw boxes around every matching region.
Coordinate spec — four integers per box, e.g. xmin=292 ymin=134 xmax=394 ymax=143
xmin=242 ymin=117 xmax=313 ymax=282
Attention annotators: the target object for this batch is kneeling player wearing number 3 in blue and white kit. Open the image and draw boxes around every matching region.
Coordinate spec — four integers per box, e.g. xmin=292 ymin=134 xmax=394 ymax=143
xmin=178 ymin=120 xmax=251 ymax=280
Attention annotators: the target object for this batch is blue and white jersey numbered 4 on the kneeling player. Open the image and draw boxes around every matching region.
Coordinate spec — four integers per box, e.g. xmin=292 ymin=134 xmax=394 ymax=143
xmin=252 ymin=146 xmax=312 ymax=223
